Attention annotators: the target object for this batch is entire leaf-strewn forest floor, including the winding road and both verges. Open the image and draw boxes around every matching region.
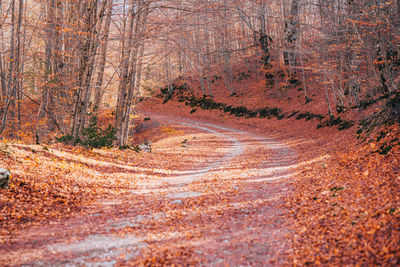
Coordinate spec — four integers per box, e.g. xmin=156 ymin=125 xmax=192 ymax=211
xmin=0 ymin=92 xmax=400 ymax=266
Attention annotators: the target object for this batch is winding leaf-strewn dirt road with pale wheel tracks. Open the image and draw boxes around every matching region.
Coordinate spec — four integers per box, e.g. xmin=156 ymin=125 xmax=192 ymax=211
xmin=0 ymin=114 xmax=295 ymax=266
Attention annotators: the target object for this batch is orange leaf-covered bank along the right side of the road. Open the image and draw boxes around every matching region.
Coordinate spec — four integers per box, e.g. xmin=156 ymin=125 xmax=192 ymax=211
xmin=138 ymin=98 xmax=400 ymax=266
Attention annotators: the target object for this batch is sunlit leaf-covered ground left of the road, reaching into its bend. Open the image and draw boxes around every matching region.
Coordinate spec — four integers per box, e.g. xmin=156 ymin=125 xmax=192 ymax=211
xmin=0 ymin=122 xmax=230 ymax=243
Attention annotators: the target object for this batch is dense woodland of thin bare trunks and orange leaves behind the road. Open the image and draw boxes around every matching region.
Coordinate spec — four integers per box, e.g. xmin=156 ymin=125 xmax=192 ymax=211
xmin=0 ymin=0 xmax=400 ymax=146
